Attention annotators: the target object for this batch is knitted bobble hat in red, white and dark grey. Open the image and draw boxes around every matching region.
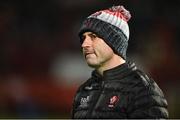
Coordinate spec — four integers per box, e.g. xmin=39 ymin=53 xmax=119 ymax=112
xmin=79 ymin=6 xmax=131 ymax=59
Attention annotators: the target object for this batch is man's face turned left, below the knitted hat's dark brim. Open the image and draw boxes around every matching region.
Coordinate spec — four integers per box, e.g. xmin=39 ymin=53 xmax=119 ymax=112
xmin=81 ymin=32 xmax=114 ymax=68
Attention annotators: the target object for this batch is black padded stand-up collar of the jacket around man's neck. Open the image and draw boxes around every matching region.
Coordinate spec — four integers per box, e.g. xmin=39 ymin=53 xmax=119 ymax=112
xmin=92 ymin=62 xmax=137 ymax=80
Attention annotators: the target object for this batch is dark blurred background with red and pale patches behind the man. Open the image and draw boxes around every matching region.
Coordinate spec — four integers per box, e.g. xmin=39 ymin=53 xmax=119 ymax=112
xmin=0 ymin=0 xmax=180 ymax=118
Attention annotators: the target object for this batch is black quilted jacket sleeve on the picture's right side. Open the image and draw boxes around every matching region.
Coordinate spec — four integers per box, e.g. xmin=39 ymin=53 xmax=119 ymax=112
xmin=128 ymin=72 xmax=168 ymax=119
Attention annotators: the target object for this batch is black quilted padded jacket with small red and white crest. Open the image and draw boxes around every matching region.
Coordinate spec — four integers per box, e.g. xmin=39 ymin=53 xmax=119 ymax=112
xmin=72 ymin=63 xmax=168 ymax=119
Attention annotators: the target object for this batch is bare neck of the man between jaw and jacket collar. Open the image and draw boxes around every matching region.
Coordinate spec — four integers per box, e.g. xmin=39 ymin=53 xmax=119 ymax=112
xmin=97 ymin=54 xmax=126 ymax=75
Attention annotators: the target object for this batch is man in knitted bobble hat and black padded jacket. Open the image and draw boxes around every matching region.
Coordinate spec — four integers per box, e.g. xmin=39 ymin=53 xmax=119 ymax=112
xmin=72 ymin=6 xmax=168 ymax=119
